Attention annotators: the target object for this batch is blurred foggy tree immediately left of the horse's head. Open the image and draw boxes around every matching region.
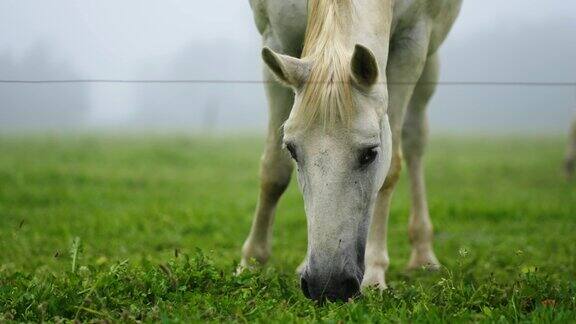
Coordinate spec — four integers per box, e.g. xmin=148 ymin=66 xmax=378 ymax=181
xmin=132 ymin=40 xmax=266 ymax=131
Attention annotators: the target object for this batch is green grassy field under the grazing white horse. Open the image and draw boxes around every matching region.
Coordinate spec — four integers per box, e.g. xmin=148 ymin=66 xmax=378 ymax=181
xmin=0 ymin=136 xmax=576 ymax=323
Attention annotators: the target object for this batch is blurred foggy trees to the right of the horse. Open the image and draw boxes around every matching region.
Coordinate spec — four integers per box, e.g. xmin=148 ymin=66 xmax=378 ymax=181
xmin=430 ymin=19 xmax=576 ymax=133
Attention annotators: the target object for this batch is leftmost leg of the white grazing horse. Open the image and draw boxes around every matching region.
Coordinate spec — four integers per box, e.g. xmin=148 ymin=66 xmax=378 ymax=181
xmin=238 ymin=66 xmax=294 ymax=271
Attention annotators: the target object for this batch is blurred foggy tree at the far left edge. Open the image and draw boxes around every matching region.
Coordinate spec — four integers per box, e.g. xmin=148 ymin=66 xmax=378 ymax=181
xmin=0 ymin=43 xmax=90 ymax=130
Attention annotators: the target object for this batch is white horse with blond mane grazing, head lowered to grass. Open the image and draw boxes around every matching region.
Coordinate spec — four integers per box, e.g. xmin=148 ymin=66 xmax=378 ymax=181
xmin=240 ymin=0 xmax=461 ymax=300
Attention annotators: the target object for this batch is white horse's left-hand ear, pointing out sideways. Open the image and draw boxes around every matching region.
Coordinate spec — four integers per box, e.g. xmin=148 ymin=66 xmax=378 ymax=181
xmin=262 ymin=47 xmax=310 ymax=88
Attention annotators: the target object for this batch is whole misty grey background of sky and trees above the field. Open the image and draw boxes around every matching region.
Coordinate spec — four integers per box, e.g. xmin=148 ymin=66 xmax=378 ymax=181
xmin=0 ymin=0 xmax=576 ymax=134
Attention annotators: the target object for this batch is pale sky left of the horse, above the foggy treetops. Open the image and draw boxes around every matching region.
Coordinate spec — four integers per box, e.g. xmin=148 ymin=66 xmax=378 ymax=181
xmin=0 ymin=0 xmax=258 ymax=78
